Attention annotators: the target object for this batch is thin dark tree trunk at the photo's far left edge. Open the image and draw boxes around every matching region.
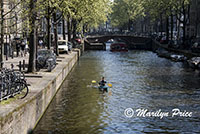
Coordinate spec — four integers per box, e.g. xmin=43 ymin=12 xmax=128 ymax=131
xmin=0 ymin=0 xmax=4 ymax=68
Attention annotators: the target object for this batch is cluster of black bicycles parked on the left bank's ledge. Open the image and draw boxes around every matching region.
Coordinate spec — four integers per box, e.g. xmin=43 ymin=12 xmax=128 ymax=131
xmin=0 ymin=68 xmax=29 ymax=101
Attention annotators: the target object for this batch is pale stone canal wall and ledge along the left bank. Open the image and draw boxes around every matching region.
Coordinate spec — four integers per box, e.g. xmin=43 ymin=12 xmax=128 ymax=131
xmin=0 ymin=50 xmax=81 ymax=134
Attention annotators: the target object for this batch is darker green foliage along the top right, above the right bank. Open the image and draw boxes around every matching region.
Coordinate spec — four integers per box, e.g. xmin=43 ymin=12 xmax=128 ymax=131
xmin=111 ymin=0 xmax=191 ymax=26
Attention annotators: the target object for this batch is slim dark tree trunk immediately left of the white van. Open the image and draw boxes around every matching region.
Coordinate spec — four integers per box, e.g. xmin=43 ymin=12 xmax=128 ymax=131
xmin=53 ymin=11 xmax=59 ymax=56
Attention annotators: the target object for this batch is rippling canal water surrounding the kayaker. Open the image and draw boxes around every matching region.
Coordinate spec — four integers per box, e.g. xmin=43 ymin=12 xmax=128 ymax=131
xmin=34 ymin=51 xmax=200 ymax=134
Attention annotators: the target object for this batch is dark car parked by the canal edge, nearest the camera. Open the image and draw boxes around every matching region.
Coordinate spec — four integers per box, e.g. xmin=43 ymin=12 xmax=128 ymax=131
xmin=37 ymin=49 xmax=56 ymax=72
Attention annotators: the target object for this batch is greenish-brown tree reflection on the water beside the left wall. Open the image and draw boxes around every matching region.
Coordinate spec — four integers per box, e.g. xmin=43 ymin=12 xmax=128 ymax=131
xmin=35 ymin=51 xmax=109 ymax=134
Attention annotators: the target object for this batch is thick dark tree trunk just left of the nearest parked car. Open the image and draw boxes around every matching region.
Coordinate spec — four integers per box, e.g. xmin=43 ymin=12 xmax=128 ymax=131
xmin=28 ymin=0 xmax=36 ymax=72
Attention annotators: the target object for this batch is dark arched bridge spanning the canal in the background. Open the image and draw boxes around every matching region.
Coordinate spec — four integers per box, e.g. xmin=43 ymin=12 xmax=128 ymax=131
xmin=85 ymin=35 xmax=152 ymax=50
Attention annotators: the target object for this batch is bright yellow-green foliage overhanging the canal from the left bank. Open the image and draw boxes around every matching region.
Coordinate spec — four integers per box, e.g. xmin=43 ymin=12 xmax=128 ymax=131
xmin=33 ymin=0 xmax=111 ymax=31
